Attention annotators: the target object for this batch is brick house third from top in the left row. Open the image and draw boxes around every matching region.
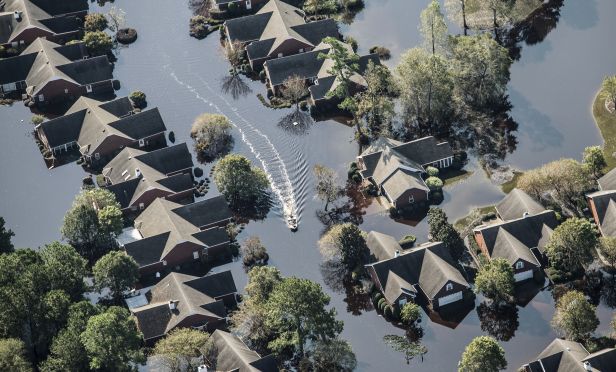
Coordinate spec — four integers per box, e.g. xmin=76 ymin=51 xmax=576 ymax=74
xmin=36 ymin=97 xmax=167 ymax=165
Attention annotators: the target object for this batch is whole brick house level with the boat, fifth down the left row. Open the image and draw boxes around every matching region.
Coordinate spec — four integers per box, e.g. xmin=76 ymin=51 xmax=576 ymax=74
xmin=119 ymin=196 xmax=232 ymax=275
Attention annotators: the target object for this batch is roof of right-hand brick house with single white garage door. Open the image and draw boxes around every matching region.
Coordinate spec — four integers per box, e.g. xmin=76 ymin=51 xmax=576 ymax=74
xmin=474 ymin=210 xmax=558 ymax=265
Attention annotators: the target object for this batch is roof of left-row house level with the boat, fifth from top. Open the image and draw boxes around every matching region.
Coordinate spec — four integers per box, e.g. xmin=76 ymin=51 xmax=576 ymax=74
xmin=124 ymin=196 xmax=232 ymax=267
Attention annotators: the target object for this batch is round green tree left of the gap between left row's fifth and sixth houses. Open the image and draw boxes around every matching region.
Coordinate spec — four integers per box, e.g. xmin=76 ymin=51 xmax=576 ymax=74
xmin=92 ymin=251 xmax=139 ymax=303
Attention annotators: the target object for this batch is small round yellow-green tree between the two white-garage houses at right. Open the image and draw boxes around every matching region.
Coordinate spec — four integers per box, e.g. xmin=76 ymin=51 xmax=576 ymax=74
xmin=475 ymin=258 xmax=515 ymax=303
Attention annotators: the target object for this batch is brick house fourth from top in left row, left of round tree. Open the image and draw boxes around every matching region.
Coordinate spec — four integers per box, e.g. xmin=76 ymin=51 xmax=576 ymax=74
xmin=102 ymin=143 xmax=195 ymax=214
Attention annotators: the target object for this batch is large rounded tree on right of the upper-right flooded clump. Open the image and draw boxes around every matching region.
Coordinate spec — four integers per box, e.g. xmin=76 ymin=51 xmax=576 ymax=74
xmin=452 ymin=34 xmax=512 ymax=111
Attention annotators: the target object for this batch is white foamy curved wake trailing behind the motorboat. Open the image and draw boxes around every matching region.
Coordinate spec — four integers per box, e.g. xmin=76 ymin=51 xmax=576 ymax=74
xmin=170 ymin=67 xmax=300 ymax=230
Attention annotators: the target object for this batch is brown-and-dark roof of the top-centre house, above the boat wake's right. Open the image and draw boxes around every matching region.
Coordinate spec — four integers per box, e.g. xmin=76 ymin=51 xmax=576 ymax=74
xmin=225 ymin=0 xmax=339 ymax=60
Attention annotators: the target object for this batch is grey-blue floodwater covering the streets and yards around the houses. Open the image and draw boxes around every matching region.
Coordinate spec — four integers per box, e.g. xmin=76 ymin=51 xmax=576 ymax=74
xmin=0 ymin=0 xmax=616 ymax=371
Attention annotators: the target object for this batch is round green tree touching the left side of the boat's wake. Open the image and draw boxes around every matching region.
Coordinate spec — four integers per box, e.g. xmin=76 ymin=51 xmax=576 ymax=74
xmin=214 ymin=154 xmax=270 ymax=212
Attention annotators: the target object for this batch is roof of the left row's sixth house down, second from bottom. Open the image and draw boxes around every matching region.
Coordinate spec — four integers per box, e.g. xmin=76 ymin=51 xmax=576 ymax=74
xmin=131 ymin=271 xmax=237 ymax=340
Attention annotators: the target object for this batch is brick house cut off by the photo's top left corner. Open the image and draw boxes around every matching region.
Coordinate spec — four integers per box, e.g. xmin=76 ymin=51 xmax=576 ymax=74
xmin=0 ymin=0 xmax=88 ymax=48
